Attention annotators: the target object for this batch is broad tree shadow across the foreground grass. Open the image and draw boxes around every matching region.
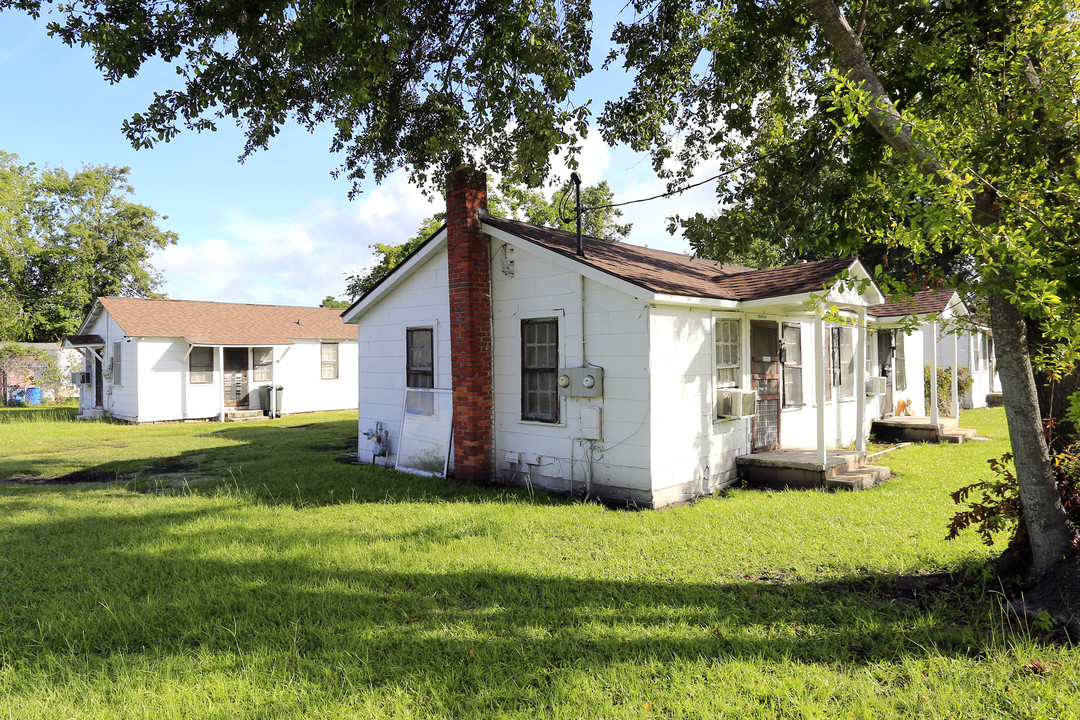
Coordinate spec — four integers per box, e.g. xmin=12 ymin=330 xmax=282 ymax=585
xmin=0 ymin=507 xmax=987 ymax=703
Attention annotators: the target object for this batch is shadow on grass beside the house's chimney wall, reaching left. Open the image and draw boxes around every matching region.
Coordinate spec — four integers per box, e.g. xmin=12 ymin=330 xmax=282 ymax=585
xmin=6 ymin=418 xmax=563 ymax=506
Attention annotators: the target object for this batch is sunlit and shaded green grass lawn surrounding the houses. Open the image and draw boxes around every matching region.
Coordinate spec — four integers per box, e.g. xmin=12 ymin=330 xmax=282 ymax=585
xmin=0 ymin=410 xmax=1080 ymax=720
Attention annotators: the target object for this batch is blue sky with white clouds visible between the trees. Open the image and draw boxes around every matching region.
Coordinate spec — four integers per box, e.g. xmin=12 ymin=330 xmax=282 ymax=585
xmin=0 ymin=8 xmax=716 ymax=304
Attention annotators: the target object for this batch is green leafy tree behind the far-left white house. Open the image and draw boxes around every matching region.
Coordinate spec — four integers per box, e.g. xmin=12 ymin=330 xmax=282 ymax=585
xmin=0 ymin=152 xmax=176 ymax=341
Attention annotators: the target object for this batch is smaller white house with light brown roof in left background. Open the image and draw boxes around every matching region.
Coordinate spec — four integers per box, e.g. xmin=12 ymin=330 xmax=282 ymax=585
xmin=65 ymin=298 xmax=356 ymax=422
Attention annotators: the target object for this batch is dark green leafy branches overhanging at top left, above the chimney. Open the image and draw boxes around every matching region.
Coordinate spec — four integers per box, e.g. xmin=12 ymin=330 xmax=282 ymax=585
xmin=0 ymin=0 xmax=592 ymax=192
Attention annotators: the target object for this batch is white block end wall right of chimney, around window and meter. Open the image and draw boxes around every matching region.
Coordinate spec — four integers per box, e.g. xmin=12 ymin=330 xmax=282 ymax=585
xmin=491 ymin=243 xmax=652 ymax=505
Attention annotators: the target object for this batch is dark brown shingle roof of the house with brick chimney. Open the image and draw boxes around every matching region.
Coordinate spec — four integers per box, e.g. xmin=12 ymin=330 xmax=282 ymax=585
xmin=483 ymin=217 xmax=854 ymax=300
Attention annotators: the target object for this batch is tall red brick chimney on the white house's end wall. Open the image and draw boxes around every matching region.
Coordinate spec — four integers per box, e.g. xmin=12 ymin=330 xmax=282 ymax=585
xmin=446 ymin=165 xmax=495 ymax=483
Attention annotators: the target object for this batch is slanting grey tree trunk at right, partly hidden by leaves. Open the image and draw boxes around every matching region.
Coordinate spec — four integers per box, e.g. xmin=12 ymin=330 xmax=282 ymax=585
xmin=806 ymin=0 xmax=1078 ymax=578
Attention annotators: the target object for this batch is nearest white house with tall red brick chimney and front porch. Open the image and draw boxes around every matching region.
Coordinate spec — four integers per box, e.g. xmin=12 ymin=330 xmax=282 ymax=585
xmin=343 ymin=168 xmax=902 ymax=507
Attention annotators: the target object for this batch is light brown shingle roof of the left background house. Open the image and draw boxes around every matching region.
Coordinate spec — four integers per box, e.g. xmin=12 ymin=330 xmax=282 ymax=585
xmin=98 ymin=298 xmax=353 ymax=345
